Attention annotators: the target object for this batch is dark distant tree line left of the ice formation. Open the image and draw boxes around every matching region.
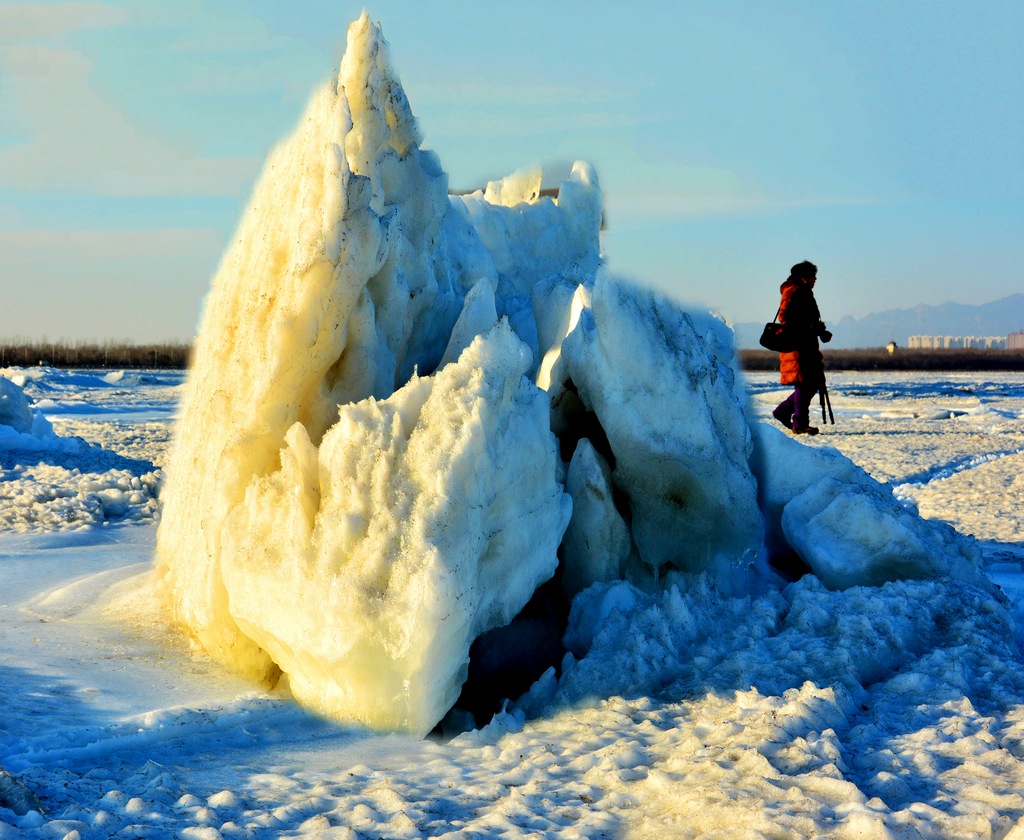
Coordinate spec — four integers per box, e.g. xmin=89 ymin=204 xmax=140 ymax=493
xmin=0 ymin=338 xmax=191 ymax=369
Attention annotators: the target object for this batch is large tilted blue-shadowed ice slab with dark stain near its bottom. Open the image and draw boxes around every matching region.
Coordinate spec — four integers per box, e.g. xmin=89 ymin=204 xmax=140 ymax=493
xmin=552 ymin=271 xmax=764 ymax=583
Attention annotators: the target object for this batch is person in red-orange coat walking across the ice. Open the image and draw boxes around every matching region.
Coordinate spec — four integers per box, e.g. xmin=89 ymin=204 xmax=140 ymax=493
xmin=772 ymin=260 xmax=831 ymax=434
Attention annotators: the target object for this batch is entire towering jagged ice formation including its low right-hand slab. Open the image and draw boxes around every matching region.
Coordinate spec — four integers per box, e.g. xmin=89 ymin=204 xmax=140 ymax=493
xmin=157 ymin=14 xmax=995 ymax=734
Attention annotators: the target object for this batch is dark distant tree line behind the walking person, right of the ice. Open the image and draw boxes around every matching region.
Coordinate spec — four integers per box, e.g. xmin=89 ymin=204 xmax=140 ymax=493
xmin=739 ymin=347 xmax=1024 ymax=371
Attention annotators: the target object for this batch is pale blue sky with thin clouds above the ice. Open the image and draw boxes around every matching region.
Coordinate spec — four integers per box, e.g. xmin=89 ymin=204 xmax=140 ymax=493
xmin=0 ymin=0 xmax=1024 ymax=342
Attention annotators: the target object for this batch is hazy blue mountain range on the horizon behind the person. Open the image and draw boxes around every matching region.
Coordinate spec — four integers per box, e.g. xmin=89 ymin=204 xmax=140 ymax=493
xmin=734 ymin=294 xmax=1024 ymax=348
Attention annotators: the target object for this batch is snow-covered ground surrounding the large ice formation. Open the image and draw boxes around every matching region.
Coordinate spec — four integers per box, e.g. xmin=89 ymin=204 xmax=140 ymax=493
xmin=0 ymin=369 xmax=1024 ymax=839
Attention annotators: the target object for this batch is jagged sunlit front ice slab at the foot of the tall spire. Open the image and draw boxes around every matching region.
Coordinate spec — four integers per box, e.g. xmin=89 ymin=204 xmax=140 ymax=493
xmin=221 ymin=323 xmax=570 ymax=734
